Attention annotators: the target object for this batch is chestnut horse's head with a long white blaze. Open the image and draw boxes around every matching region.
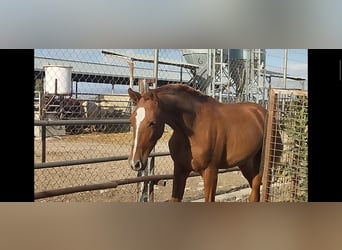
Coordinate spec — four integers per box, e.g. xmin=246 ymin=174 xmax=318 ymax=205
xmin=128 ymin=88 xmax=165 ymax=171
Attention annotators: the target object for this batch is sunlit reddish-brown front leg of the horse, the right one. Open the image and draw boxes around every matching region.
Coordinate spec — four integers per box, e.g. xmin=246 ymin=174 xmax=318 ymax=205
xmin=201 ymin=167 xmax=218 ymax=202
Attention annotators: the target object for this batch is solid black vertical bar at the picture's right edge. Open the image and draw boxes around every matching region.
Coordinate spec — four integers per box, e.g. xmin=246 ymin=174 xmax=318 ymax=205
xmin=308 ymin=49 xmax=342 ymax=202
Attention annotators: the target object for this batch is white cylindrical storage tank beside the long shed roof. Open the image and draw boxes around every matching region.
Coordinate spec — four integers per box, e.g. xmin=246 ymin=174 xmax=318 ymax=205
xmin=44 ymin=65 xmax=72 ymax=95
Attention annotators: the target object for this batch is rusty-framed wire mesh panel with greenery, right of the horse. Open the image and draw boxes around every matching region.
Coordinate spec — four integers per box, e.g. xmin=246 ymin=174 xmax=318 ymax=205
xmin=262 ymin=89 xmax=308 ymax=202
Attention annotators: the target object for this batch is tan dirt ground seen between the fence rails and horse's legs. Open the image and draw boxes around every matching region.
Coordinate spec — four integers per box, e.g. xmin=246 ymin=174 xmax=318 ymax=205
xmin=34 ymin=131 xmax=247 ymax=202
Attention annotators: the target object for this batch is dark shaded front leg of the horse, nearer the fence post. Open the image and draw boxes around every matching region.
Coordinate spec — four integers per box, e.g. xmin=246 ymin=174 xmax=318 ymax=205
xmin=170 ymin=163 xmax=191 ymax=202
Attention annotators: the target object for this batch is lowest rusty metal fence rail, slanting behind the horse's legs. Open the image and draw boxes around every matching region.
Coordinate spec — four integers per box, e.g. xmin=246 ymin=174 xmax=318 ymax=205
xmin=34 ymin=167 xmax=240 ymax=200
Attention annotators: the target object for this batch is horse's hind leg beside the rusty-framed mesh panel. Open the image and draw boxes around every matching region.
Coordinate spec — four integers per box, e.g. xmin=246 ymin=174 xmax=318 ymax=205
xmin=240 ymin=151 xmax=262 ymax=202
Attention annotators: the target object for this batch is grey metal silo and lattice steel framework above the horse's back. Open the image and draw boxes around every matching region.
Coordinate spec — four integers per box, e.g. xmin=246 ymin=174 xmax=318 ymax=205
xmin=181 ymin=49 xmax=266 ymax=102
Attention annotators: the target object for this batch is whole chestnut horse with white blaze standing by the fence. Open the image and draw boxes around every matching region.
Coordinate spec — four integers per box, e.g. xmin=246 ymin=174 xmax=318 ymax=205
xmin=128 ymin=84 xmax=266 ymax=202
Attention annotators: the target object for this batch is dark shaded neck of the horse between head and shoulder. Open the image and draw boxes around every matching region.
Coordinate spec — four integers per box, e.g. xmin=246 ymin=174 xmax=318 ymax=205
xmin=160 ymin=95 xmax=198 ymax=135
